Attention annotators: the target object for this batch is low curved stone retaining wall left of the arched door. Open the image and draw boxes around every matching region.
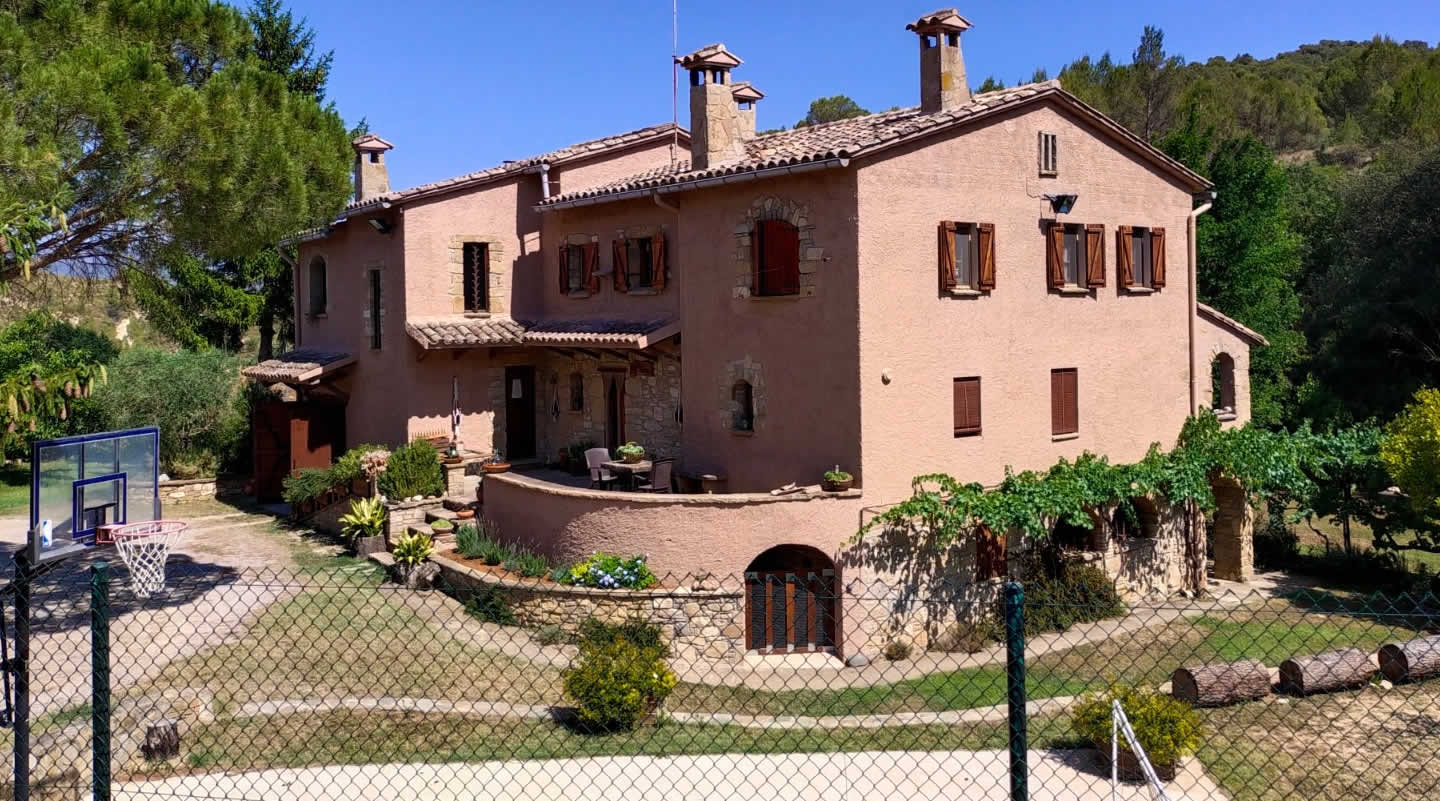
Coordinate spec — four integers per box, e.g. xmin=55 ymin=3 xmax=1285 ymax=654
xmin=431 ymin=555 xmax=744 ymax=661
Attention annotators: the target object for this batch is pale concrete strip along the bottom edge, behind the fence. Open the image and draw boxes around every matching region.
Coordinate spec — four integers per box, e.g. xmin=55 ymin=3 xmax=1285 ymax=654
xmin=114 ymin=751 xmax=1225 ymax=801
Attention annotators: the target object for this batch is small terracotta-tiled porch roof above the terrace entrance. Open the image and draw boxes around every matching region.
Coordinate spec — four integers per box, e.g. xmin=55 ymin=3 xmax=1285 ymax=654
xmin=405 ymin=316 xmax=675 ymax=350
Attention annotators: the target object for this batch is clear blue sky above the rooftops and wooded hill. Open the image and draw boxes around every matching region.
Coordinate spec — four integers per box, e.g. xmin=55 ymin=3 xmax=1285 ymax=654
xmin=286 ymin=0 xmax=1440 ymax=189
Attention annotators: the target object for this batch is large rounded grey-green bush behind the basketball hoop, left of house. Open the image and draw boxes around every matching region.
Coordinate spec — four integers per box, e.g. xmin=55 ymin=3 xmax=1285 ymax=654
xmin=95 ymin=347 xmax=249 ymax=478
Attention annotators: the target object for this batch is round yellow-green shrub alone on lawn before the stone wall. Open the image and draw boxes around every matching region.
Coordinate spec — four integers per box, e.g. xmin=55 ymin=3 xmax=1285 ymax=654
xmin=563 ymin=637 xmax=675 ymax=732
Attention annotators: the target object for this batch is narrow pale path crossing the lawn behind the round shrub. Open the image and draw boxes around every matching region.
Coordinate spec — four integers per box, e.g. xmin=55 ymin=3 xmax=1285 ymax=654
xmin=230 ymin=696 xmax=1079 ymax=730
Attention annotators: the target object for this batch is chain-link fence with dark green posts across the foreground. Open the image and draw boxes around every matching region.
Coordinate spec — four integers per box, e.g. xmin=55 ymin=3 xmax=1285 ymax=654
xmin=3 ymin=550 xmax=1440 ymax=801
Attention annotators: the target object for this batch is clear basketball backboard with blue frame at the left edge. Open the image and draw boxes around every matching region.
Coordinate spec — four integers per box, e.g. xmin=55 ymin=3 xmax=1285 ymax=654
xmin=29 ymin=428 xmax=160 ymax=565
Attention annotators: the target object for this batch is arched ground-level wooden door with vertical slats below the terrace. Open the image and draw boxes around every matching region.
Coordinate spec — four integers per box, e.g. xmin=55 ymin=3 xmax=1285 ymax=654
xmin=744 ymin=545 xmax=840 ymax=653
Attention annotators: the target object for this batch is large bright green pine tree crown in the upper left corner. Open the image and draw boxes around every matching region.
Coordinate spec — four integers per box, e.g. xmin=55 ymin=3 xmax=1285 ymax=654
xmin=0 ymin=0 xmax=350 ymax=344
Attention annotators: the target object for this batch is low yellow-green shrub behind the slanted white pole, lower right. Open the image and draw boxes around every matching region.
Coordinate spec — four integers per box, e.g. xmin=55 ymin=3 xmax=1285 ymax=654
xmin=1070 ymin=686 xmax=1201 ymax=765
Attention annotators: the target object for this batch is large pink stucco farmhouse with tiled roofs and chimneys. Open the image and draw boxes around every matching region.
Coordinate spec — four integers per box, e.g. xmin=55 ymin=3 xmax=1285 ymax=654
xmin=248 ymin=9 xmax=1264 ymax=651
